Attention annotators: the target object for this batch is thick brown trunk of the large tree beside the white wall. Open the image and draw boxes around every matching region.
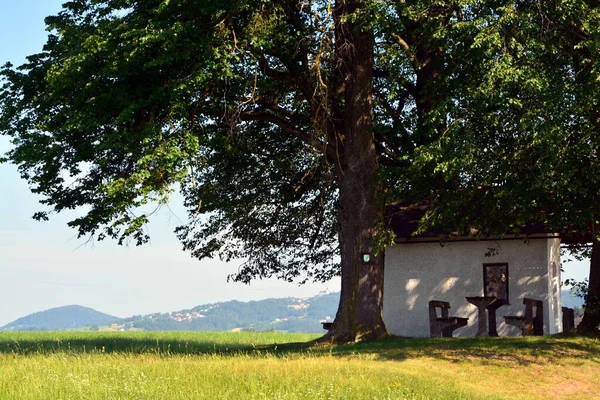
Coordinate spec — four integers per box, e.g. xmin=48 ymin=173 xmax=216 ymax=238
xmin=325 ymin=0 xmax=387 ymax=342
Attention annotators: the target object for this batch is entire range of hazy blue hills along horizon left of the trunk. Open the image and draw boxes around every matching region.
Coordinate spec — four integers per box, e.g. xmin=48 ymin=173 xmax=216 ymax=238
xmin=0 ymin=292 xmax=340 ymax=333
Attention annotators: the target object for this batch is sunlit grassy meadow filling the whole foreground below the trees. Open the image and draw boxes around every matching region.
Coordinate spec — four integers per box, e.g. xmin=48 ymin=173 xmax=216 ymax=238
xmin=0 ymin=332 xmax=600 ymax=400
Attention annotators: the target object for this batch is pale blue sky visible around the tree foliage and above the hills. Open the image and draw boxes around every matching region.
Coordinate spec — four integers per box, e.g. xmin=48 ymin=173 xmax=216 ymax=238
xmin=0 ymin=0 xmax=588 ymax=326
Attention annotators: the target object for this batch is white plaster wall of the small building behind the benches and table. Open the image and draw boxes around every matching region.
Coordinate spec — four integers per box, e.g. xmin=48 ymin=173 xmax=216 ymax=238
xmin=383 ymin=239 xmax=562 ymax=337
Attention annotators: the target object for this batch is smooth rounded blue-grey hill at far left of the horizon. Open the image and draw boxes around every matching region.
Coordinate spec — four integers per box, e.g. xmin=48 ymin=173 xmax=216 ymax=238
xmin=0 ymin=306 xmax=119 ymax=331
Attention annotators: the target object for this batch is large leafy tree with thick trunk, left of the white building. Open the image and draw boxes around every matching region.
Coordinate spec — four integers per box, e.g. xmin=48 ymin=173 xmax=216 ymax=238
xmin=0 ymin=0 xmax=528 ymax=341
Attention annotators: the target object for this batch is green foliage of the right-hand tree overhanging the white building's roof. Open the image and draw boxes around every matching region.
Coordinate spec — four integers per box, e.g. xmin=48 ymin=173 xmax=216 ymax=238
xmin=406 ymin=1 xmax=600 ymax=241
